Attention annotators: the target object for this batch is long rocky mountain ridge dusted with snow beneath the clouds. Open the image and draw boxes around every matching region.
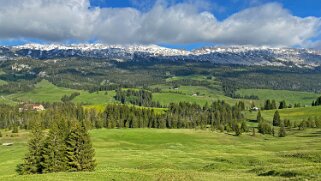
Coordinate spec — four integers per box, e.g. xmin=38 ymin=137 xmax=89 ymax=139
xmin=0 ymin=44 xmax=321 ymax=68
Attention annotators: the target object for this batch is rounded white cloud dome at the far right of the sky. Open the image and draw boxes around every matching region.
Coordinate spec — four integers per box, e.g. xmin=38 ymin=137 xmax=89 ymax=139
xmin=214 ymin=4 xmax=321 ymax=46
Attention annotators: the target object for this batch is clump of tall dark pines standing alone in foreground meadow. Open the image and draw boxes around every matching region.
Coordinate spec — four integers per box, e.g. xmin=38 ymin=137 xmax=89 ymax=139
xmin=17 ymin=120 xmax=96 ymax=174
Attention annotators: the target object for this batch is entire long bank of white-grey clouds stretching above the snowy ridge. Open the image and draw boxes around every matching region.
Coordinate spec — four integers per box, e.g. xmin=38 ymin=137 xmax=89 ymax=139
xmin=0 ymin=0 xmax=321 ymax=46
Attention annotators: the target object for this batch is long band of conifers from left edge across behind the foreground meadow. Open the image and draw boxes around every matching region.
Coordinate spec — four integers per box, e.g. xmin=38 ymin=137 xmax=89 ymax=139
xmin=0 ymin=101 xmax=245 ymax=134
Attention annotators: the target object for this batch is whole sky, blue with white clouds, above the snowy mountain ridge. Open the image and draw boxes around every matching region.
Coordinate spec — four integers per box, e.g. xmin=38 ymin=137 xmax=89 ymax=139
xmin=0 ymin=0 xmax=321 ymax=49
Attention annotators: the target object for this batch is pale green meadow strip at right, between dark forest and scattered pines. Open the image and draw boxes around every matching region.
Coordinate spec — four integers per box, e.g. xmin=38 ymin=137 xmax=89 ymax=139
xmin=237 ymin=89 xmax=321 ymax=105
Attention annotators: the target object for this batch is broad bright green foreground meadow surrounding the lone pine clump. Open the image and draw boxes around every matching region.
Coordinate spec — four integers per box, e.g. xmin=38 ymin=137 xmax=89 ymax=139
xmin=0 ymin=129 xmax=321 ymax=181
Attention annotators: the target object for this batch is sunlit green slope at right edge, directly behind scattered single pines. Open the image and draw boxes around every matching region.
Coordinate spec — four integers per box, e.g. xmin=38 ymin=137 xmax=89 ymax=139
xmin=246 ymin=106 xmax=321 ymax=121
